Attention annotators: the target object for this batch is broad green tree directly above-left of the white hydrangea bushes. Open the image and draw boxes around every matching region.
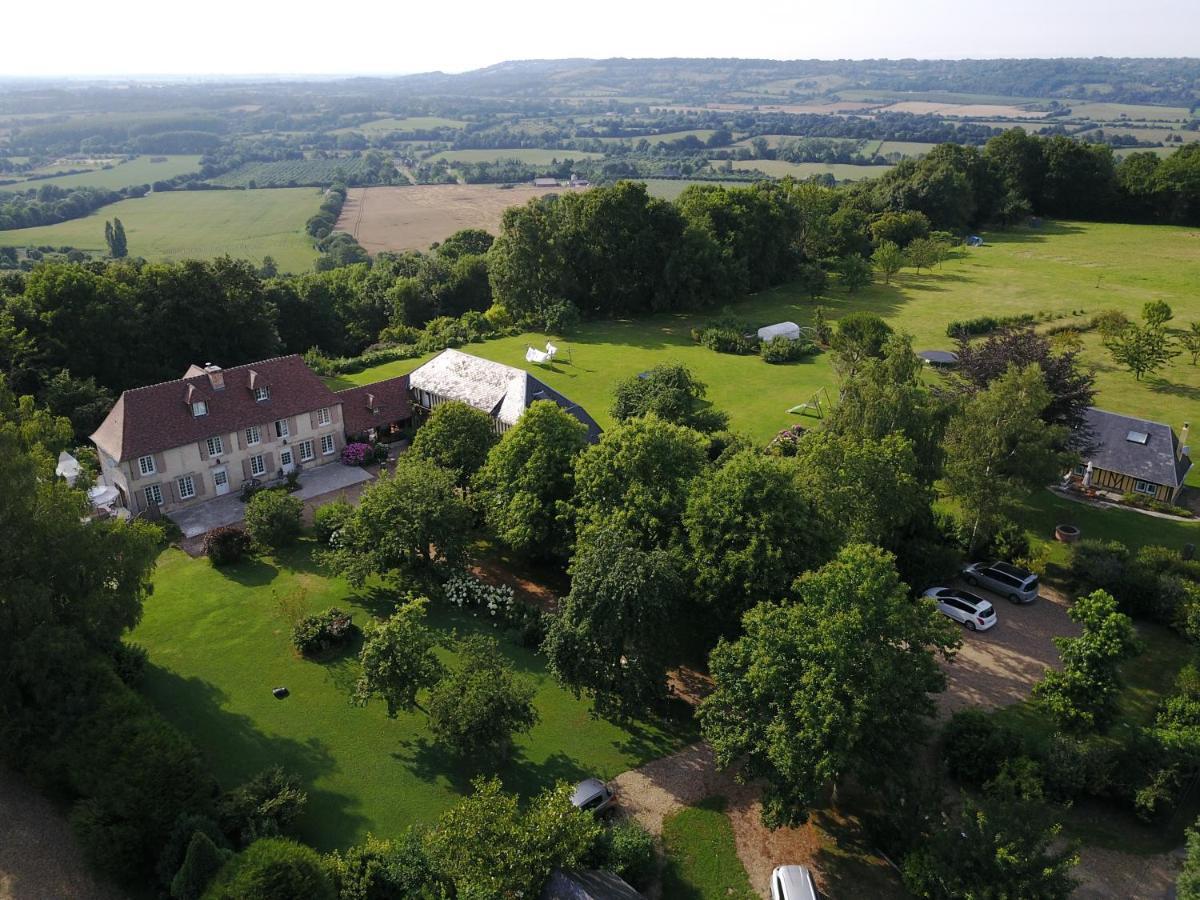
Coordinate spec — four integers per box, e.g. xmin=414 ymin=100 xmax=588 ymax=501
xmin=322 ymin=454 xmax=472 ymax=586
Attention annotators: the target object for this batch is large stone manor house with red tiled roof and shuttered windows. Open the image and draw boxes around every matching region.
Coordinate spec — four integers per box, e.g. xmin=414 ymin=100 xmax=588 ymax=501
xmin=91 ymin=355 xmax=346 ymax=514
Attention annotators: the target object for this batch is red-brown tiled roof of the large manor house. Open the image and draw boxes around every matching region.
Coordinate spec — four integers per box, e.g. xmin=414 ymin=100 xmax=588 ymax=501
xmin=91 ymin=355 xmax=340 ymax=462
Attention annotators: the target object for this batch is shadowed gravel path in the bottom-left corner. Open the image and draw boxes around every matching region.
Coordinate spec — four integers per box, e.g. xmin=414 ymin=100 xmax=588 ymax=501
xmin=0 ymin=768 xmax=125 ymax=900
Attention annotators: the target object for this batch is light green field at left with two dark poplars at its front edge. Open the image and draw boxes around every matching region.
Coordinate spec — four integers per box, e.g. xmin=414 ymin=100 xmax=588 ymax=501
xmin=0 ymin=187 xmax=320 ymax=272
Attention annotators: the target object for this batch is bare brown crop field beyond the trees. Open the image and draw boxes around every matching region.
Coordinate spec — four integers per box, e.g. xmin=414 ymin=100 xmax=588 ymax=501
xmin=337 ymin=185 xmax=585 ymax=253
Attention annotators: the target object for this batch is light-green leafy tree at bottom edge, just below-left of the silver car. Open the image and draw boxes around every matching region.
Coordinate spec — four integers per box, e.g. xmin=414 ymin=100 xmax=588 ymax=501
xmin=425 ymin=779 xmax=601 ymax=900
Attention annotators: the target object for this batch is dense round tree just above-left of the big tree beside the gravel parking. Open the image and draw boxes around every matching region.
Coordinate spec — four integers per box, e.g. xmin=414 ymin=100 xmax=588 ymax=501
xmin=684 ymin=450 xmax=833 ymax=628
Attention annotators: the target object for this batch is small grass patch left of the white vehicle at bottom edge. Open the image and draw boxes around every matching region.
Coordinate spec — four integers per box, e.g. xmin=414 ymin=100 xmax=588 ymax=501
xmin=662 ymin=797 xmax=755 ymax=900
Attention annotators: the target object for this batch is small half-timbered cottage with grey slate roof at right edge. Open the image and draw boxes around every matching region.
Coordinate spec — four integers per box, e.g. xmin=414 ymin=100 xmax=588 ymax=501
xmin=1072 ymin=407 xmax=1192 ymax=503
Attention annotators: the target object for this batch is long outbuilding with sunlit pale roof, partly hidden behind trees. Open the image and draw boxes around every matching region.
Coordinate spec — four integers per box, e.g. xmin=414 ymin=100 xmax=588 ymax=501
xmin=408 ymin=349 xmax=601 ymax=443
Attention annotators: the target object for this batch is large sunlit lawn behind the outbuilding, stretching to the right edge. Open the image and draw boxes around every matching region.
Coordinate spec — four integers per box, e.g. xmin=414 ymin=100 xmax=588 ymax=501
xmin=337 ymin=222 xmax=1200 ymax=453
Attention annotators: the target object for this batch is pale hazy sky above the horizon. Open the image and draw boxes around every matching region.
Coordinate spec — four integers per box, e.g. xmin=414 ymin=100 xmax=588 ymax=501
xmin=0 ymin=0 xmax=1200 ymax=76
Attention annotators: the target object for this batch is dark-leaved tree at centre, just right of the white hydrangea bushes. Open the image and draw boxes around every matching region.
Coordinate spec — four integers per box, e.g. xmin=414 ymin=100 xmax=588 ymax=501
xmin=542 ymin=523 xmax=686 ymax=714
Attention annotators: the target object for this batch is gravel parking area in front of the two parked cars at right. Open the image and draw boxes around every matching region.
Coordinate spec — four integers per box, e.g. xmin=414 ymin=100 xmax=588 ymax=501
xmin=937 ymin=584 xmax=1080 ymax=715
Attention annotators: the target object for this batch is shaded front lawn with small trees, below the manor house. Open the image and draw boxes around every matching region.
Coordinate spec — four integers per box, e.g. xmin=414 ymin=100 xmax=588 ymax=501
xmin=131 ymin=541 xmax=694 ymax=850
